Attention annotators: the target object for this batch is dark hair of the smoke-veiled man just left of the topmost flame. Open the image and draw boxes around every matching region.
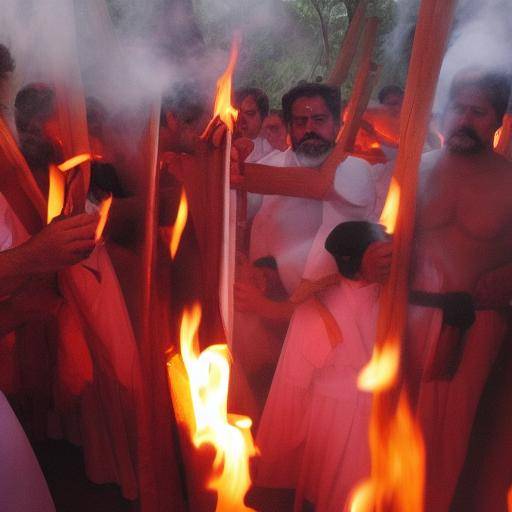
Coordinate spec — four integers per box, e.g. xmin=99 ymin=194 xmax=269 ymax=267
xmin=160 ymin=82 xmax=206 ymax=126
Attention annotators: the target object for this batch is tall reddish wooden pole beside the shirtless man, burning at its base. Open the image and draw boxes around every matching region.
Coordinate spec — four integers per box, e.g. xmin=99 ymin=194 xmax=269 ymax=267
xmin=362 ymin=0 xmax=457 ymax=512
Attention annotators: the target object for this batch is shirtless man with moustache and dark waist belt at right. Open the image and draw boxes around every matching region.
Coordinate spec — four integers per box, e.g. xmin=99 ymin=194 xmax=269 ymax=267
xmin=363 ymin=70 xmax=512 ymax=512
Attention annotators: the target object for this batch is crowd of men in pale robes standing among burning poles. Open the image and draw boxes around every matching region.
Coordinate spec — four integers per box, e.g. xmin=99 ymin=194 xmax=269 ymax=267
xmin=0 ymin=20 xmax=512 ymax=512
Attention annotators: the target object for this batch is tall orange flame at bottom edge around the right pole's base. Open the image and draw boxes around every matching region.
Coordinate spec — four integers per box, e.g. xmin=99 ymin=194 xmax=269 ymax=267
xmin=348 ymin=391 xmax=425 ymax=512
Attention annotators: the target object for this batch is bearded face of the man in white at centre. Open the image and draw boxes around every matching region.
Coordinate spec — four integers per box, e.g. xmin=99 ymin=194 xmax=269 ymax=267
xmin=290 ymin=96 xmax=339 ymax=158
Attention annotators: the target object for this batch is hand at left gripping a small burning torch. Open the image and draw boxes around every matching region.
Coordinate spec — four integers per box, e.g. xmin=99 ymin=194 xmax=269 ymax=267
xmin=25 ymin=213 xmax=99 ymax=273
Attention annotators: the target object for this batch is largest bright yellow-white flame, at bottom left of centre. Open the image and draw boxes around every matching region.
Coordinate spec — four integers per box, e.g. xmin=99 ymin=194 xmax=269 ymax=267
xmin=168 ymin=304 xmax=256 ymax=512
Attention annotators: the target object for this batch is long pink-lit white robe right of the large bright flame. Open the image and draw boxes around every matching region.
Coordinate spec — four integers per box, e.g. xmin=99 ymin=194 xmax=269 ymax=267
xmin=256 ymin=280 xmax=379 ymax=504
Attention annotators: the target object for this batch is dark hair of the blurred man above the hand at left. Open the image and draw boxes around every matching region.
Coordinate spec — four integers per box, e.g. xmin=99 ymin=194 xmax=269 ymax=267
xmin=14 ymin=83 xmax=55 ymax=130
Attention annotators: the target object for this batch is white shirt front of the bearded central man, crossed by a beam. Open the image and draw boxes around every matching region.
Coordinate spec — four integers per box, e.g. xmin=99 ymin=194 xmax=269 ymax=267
xmin=249 ymin=149 xmax=322 ymax=294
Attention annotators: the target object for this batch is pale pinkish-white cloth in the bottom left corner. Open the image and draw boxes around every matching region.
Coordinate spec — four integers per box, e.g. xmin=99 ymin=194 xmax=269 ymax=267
xmin=0 ymin=392 xmax=55 ymax=512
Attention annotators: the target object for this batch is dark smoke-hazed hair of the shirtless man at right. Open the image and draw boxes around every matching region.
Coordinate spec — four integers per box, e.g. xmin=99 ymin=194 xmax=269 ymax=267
xmin=448 ymin=68 xmax=511 ymax=124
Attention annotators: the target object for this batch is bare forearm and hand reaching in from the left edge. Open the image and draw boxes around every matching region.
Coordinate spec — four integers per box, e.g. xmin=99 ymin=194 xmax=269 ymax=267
xmin=0 ymin=214 xmax=98 ymax=296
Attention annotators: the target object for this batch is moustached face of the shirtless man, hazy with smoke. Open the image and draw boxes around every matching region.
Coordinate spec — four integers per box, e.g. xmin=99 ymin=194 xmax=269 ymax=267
xmin=443 ymin=87 xmax=499 ymax=154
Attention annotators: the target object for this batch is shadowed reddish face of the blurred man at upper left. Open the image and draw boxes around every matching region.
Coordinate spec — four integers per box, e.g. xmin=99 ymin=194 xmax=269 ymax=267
xmin=16 ymin=108 xmax=62 ymax=167
